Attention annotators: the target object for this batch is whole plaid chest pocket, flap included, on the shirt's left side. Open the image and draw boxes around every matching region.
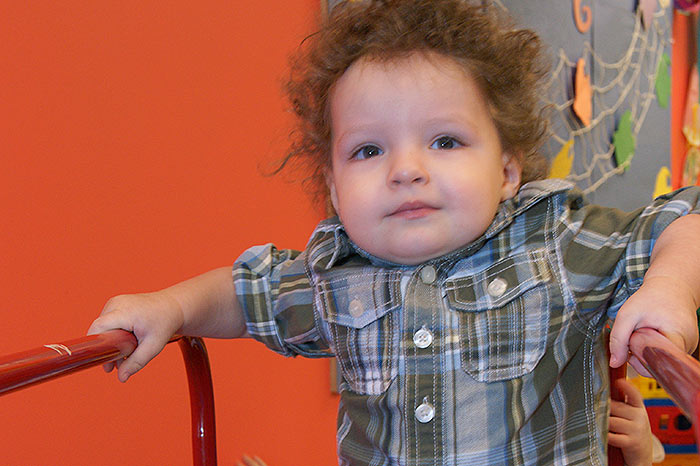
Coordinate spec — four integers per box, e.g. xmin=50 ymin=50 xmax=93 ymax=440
xmin=316 ymin=271 xmax=401 ymax=395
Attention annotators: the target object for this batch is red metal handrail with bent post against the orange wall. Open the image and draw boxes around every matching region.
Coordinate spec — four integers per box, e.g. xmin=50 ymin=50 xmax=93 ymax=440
xmin=0 ymin=330 xmax=217 ymax=466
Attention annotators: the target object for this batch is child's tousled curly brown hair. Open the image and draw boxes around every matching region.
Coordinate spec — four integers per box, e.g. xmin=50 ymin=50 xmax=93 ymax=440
xmin=276 ymin=0 xmax=549 ymax=205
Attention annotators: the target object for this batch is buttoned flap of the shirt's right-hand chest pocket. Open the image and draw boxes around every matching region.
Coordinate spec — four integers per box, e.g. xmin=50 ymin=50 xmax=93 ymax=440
xmin=445 ymin=249 xmax=552 ymax=312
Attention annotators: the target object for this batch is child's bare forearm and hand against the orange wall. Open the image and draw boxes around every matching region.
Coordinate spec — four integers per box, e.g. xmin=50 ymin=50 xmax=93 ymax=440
xmin=88 ymin=266 xmax=247 ymax=382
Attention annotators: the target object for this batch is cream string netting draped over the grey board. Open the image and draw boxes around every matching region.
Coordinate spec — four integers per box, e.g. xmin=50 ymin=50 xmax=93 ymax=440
xmin=546 ymin=6 xmax=670 ymax=193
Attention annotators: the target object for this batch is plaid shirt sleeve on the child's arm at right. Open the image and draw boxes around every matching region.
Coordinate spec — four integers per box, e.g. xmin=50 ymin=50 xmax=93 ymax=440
xmin=559 ymin=187 xmax=700 ymax=319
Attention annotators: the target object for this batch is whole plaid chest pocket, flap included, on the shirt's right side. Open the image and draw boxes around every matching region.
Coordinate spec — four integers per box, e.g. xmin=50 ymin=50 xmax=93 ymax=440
xmin=445 ymin=250 xmax=552 ymax=382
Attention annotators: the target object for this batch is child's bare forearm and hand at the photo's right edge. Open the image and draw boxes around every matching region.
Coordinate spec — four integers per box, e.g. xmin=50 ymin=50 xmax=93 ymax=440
xmin=610 ymin=214 xmax=700 ymax=374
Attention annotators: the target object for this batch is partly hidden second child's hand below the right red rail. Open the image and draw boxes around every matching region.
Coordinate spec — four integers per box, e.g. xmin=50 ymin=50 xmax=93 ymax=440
xmin=608 ymin=379 xmax=653 ymax=466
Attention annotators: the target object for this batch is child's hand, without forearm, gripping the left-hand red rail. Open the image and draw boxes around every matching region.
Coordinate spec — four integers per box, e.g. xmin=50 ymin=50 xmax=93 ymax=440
xmin=88 ymin=291 xmax=184 ymax=382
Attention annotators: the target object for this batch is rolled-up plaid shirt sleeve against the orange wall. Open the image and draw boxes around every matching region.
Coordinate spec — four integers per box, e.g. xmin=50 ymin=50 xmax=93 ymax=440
xmin=233 ymin=244 xmax=333 ymax=357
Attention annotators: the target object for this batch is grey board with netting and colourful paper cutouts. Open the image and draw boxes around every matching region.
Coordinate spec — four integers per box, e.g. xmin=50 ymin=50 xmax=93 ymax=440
xmin=491 ymin=0 xmax=671 ymax=209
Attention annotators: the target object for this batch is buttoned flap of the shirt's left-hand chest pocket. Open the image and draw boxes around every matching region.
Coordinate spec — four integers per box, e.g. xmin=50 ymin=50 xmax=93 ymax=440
xmin=316 ymin=268 xmax=401 ymax=329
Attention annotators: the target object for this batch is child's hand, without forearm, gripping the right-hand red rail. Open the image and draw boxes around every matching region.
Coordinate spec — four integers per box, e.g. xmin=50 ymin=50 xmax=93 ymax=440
xmin=610 ymin=276 xmax=698 ymax=377
